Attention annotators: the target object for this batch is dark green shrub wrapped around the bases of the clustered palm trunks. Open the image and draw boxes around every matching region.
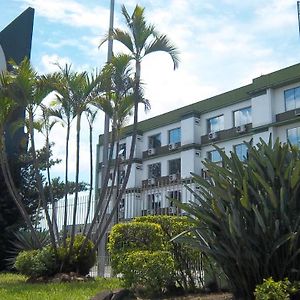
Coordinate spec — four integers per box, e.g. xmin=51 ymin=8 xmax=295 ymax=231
xmin=58 ymin=234 xmax=96 ymax=275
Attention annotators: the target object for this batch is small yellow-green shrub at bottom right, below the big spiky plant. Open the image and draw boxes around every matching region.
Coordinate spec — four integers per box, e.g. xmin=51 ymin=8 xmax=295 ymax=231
xmin=254 ymin=277 xmax=291 ymax=300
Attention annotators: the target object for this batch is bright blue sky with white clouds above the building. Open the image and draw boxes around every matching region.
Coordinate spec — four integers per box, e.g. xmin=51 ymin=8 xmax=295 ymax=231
xmin=0 ymin=0 xmax=300 ymax=181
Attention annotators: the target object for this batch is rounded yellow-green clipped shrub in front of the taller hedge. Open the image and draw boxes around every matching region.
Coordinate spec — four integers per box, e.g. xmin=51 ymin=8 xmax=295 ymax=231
xmin=115 ymin=250 xmax=174 ymax=295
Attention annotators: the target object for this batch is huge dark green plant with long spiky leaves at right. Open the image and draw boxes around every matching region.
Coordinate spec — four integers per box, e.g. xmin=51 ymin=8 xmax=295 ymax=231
xmin=182 ymin=140 xmax=300 ymax=300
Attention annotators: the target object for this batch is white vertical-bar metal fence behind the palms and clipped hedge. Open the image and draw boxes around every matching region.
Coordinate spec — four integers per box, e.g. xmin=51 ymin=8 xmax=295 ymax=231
xmin=40 ymin=178 xmax=201 ymax=277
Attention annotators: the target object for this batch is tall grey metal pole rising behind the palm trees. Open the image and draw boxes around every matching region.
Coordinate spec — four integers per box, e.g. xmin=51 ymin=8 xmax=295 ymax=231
xmin=98 ymin=0 xmax=115 ymax=276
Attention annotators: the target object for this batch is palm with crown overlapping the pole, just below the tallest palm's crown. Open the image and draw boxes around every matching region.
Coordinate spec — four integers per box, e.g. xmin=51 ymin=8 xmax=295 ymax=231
xmin=81 ymin=54 xmax=134 ymax=249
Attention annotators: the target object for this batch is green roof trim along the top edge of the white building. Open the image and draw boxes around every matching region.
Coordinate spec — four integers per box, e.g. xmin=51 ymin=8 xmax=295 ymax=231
xmin=99 ymin=64 xmax=300 ymax=144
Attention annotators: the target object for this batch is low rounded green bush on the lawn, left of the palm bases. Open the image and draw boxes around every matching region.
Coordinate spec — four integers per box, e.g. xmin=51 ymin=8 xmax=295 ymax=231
xmin=14 ymin=247 xmax=57 ymax=278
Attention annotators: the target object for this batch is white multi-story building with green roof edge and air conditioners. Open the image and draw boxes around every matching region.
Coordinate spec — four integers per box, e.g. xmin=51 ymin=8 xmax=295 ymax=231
xmin=96 ymin=64 xmax=300 ymax=220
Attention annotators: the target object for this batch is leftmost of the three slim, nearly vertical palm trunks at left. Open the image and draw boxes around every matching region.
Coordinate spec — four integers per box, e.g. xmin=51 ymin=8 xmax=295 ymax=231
xmin=63 ymin=120 xmax=71 ymax=248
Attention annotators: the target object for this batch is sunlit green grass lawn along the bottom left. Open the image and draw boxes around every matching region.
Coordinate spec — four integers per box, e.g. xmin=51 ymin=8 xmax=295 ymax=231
xmin=0 ymin=273 xmax=121 ymax=300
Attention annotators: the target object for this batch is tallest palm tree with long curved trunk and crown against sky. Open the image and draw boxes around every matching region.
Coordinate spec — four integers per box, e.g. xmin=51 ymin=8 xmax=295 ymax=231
xmin=96 ymin=5 xmax=179 ymax=248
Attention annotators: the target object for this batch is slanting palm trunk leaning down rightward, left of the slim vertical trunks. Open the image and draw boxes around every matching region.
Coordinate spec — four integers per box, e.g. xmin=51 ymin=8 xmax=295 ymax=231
xmin=28 ymin=109 xmax=57 ymax=255
